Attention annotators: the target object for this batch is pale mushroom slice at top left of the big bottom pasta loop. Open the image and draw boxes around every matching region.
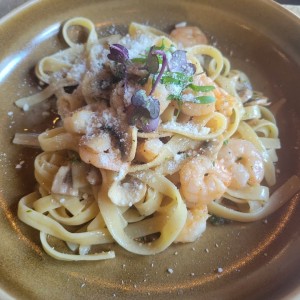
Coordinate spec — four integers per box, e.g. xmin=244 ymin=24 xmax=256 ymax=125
xmin=108 ymin=176 xmax=147 ymax=206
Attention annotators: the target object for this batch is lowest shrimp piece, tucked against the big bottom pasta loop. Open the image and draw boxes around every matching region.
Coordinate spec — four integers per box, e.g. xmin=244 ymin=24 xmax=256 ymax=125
xmin=175 ymin=205 xmax=209 ymax=243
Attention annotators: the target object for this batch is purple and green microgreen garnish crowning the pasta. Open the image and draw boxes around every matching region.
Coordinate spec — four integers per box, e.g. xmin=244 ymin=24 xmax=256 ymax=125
xmin=107 ymin=41 xmax=215 ymax=132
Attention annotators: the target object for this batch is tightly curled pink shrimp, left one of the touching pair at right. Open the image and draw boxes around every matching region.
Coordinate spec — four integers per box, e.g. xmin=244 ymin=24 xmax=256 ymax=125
xmin=179 ymin=156 xmax=231 ymax=208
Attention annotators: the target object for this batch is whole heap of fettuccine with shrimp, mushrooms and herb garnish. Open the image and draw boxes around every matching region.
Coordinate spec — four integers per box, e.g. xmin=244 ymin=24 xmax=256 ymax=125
xmin=14 ymin=17 xmax=300 ymax=260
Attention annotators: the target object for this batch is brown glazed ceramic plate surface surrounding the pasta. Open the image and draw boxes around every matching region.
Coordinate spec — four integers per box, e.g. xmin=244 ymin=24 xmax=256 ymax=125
xmin=0 ymin=0 xmax=300 ymax=299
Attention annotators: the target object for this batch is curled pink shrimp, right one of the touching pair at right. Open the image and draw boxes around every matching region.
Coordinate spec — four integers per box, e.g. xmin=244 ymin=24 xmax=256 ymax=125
xmin=218 ymin=139 xmax=264 ymax=189
